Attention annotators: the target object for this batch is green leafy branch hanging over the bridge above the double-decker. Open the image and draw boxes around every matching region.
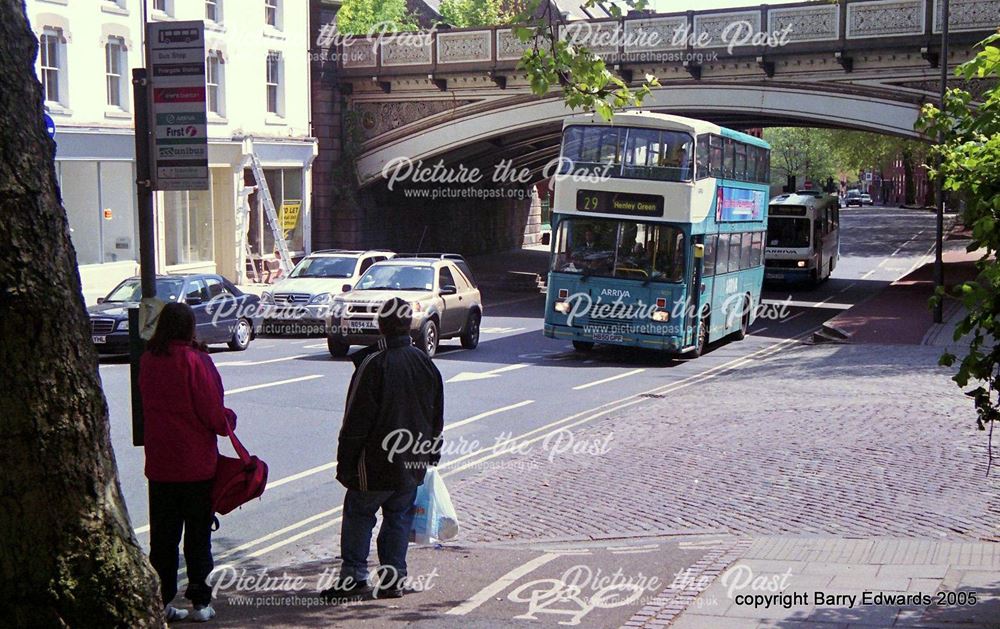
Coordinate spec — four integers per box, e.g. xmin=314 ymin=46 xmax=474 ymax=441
xmin=513 ymin=0 xmax=660 ymax=120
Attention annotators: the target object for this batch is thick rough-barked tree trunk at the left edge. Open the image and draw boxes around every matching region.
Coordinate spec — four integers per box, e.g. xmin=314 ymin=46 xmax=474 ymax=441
xmin=0 ymin=0 xmax=164 ymax=627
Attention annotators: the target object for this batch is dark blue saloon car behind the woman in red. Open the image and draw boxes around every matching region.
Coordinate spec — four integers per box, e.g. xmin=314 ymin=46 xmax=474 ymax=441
xmin=87 ymin=274 xmax=260 ymax=354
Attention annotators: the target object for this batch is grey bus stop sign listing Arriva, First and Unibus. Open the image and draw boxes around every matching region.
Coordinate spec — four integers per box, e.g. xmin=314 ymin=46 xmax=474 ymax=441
xmin=146 ymin=21 xmax=209 ymax=190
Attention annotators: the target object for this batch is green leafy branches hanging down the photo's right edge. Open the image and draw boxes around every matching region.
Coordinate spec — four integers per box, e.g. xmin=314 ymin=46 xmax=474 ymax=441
xmin=917 ymin=33 xmax=1000 ymax=429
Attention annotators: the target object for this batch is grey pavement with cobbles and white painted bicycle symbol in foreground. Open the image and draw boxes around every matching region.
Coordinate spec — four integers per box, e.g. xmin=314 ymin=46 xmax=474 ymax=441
xmin=207 ymin=341 xmax=1000 ymax=628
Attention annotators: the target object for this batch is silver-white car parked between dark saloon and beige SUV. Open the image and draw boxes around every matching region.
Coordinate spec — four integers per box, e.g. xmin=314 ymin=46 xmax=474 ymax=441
xmin=260 ymin=249 xmax=396 ymax=332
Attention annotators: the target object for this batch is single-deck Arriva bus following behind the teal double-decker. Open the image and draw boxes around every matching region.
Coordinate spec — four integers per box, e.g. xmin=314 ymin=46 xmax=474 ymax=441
xmin=764 ymin=190 xmax=840 ymax=284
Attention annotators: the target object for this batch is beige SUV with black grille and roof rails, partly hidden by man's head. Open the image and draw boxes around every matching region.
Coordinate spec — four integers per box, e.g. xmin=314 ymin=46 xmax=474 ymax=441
xmin=327 ymin=254 xmax=483 ymax=357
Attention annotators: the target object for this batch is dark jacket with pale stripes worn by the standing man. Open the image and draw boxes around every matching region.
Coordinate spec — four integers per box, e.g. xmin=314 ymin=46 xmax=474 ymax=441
xmin=337 ymin=335 xmax=444 ymax=491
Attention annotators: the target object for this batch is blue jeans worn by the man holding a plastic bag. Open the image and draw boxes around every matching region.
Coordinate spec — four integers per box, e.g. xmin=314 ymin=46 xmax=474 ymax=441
xmin=340 ymin=487 xmax=417 ymax=587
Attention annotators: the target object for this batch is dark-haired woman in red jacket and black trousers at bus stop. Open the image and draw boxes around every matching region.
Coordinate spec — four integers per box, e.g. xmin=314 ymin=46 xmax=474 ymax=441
xmin=139 ymin=303 xmax=236 ymax=621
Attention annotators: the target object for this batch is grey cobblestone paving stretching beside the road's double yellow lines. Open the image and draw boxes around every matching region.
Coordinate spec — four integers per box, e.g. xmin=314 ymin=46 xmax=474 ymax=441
xmin=450 ymin=345 xmax=1000 ymax=542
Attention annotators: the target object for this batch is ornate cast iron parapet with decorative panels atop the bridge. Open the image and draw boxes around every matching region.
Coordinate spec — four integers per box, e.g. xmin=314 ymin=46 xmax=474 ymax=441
xmin=337 ymin=0 xmax=1000 ymax=83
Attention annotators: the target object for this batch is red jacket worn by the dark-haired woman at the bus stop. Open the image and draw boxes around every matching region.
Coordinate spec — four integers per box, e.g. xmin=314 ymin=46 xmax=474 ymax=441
xmin=139 ymin=342 xmax=235 ymax=483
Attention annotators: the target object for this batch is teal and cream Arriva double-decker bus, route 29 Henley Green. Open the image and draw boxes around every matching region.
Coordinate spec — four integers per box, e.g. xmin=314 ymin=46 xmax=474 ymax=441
xmin=544 ymin=111 xmax=770 ymax=357
